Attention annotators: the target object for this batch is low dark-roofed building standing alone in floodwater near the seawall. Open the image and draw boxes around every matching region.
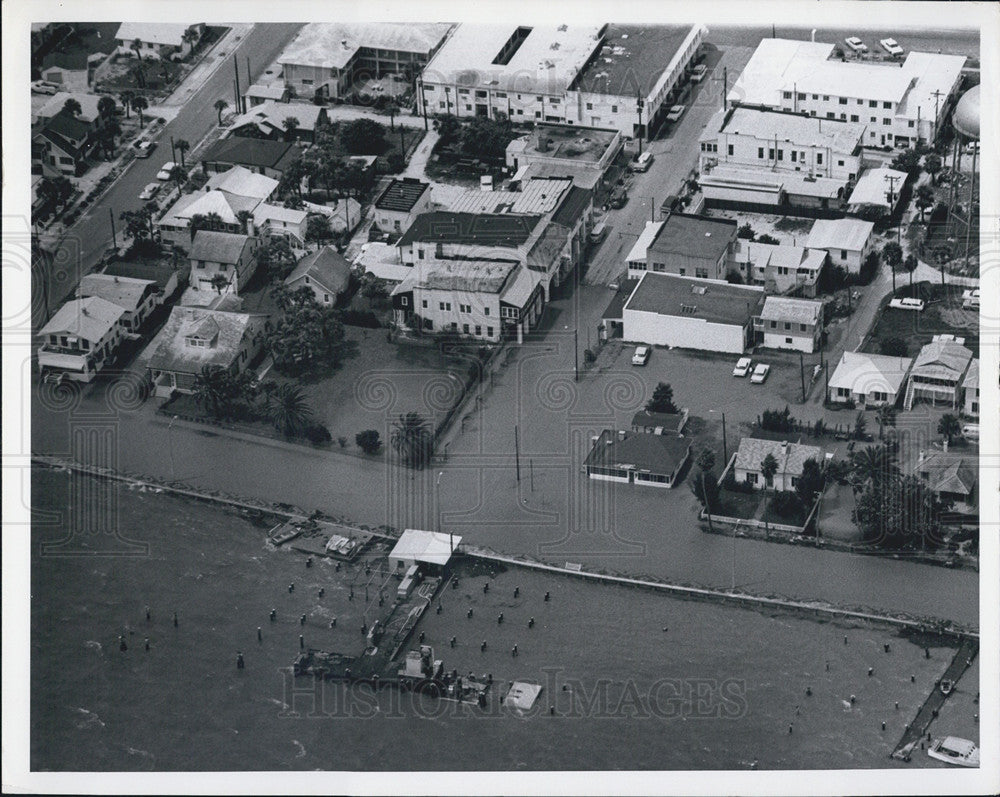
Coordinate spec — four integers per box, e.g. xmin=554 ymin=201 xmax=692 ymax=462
xmin=584 ymin=429 xmax=691 ymax=488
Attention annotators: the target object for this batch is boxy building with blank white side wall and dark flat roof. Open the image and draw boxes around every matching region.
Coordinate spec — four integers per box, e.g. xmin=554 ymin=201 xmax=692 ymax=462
xmin=622 ymin=272 xmax=765 ymax=354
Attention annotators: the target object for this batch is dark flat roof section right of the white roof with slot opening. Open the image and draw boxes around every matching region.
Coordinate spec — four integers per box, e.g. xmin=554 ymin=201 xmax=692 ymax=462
xmin=573 ymin=22 xmax=700 ymax=97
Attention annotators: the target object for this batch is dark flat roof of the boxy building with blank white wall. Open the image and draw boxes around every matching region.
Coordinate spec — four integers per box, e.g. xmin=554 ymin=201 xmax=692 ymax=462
xmin=625 ymin=271 xmax=765 ymax=326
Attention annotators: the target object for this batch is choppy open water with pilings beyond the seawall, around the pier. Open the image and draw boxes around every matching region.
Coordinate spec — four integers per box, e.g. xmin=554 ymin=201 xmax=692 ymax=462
xmin=31 ymin=470 xmax=979 ymax=771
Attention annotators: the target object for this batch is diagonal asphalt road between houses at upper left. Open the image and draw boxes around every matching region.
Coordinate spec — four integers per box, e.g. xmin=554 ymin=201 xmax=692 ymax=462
xmin=37 ymin=23 xmax=302 ymax=324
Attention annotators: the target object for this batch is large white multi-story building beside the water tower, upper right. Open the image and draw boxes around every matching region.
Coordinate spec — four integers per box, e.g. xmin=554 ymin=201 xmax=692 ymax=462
xmin=728 ymin=39 xmax=966 ymax=147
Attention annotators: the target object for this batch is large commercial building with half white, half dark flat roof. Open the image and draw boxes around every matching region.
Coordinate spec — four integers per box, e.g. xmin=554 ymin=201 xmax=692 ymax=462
xmin=418 ymin=23 xmax=707 ymax=136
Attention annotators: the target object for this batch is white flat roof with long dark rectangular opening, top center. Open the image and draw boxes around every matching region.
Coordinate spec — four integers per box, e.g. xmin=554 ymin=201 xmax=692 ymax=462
xmin=423 ymin=23 xmax=603 ymax=95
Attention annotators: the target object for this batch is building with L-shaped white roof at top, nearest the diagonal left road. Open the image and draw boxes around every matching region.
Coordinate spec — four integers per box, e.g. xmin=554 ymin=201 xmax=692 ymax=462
xmin=278 ymin=22 xmax=452 ymax=99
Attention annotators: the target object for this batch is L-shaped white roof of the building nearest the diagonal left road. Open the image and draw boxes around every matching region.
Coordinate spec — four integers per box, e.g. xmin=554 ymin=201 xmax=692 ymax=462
xmin=278 ymin=22 xmax=451 ymax=69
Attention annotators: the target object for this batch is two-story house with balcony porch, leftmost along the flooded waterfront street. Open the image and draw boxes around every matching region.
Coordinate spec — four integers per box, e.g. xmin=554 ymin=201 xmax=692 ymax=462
xmin=38 ymin=296 xmax=125 ymax=382
